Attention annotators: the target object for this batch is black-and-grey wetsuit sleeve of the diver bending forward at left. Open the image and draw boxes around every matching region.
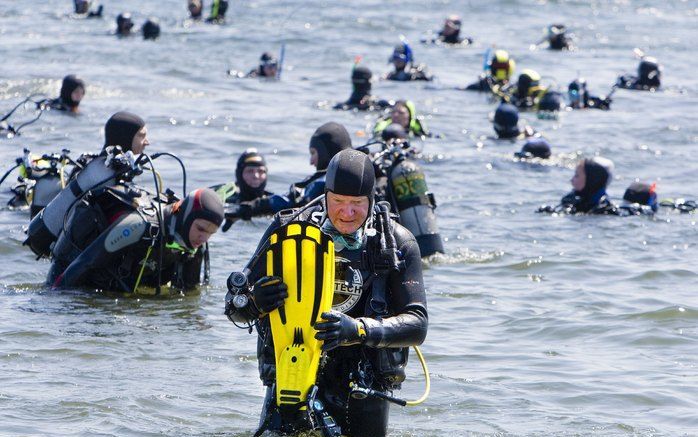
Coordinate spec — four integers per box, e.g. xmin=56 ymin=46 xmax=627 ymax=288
xmin=53 ymin=212 xmax=149 ymax=291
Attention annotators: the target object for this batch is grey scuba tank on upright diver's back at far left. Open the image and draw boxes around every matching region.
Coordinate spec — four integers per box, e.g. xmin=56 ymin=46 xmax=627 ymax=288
xmin=24 ymin=146 xmax=136 ymax=257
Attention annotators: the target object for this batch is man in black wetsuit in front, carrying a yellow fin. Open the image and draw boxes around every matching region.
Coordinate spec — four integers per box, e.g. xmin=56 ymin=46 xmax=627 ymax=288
xmin=225 ymin=150 xmax=428 ymax=437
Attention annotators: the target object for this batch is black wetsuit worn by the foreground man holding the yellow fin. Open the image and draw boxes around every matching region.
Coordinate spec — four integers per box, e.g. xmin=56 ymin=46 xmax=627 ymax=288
xmin=226 ymin=207 xmax=428 ymax=437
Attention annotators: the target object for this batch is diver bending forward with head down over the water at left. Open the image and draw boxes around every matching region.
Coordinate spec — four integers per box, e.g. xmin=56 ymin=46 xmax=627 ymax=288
xmin=46 ymin=185 xmax=223 ymax=294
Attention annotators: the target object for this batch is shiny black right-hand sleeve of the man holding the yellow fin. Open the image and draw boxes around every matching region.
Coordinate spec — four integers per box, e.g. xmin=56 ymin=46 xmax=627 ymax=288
xmin=360 ymin=224 xmax=429 ymax=348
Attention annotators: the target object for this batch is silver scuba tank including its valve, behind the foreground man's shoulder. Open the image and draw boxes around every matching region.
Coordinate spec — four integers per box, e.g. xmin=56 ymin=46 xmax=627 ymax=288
xmin=373 ymin=141 xmax=444 ymax=257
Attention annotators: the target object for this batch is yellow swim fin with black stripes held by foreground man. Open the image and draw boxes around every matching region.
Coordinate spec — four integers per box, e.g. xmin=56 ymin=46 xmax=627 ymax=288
xmin=266 ymin=222 xmax=334 ymax=409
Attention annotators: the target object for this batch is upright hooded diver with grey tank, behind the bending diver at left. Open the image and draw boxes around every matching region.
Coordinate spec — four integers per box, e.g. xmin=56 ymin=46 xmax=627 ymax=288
xmin=24 ymin=111 xmax=150 ymax=257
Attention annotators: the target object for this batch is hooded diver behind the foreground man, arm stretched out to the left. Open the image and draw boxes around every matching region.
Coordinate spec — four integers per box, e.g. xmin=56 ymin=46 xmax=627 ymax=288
xmin=224 ymin=122 xmax=351 ymax=223
